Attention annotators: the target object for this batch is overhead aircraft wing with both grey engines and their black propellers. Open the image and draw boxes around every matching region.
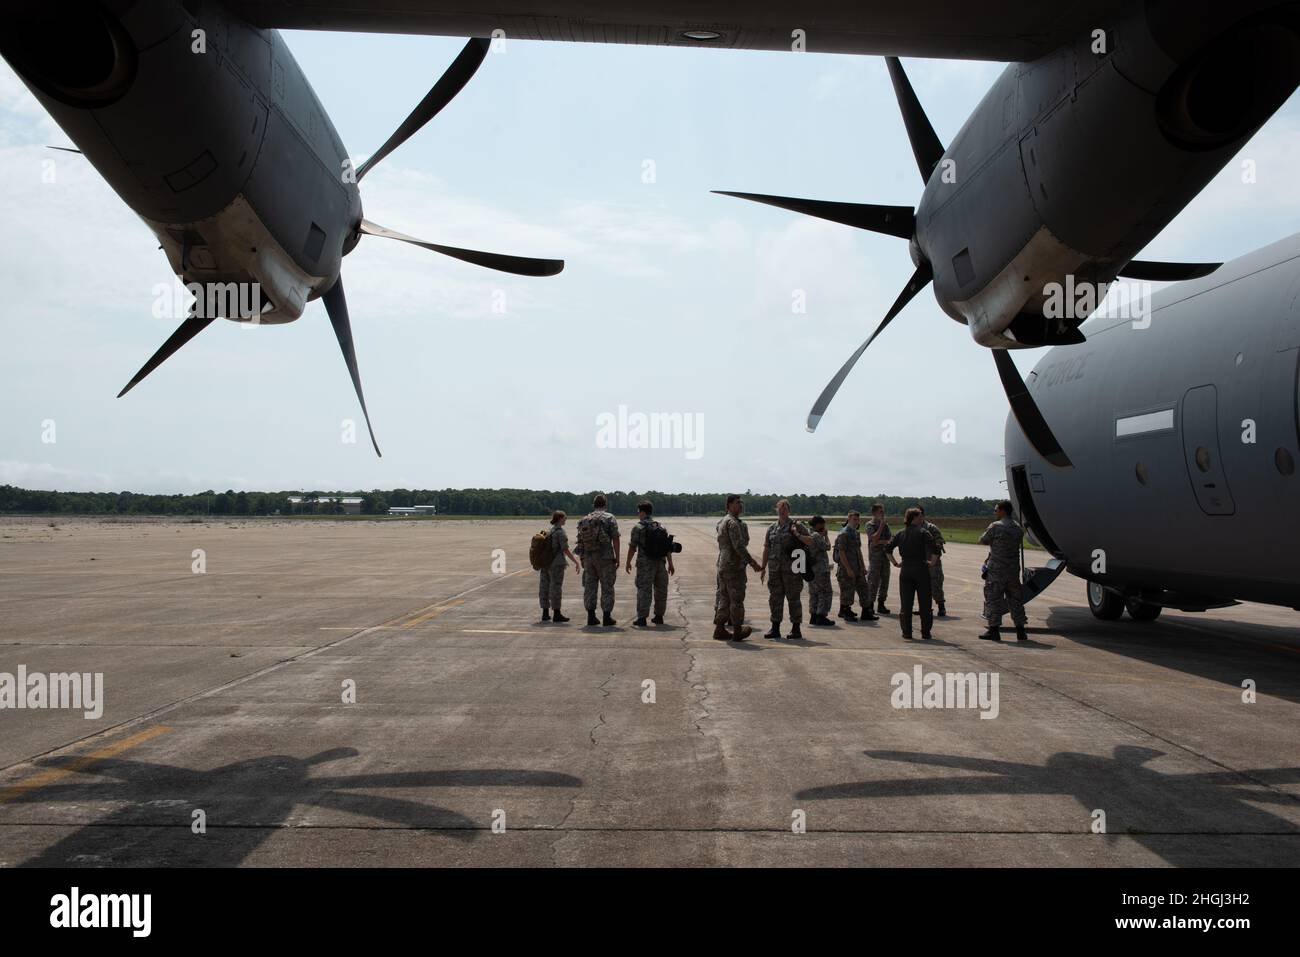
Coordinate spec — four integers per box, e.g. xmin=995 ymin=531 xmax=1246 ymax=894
xmin=0 ymin=0 xmax=1300 ymax=468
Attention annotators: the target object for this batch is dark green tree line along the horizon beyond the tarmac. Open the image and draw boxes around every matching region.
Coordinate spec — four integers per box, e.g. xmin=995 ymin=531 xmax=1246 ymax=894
xmin=0 ymin=485 xmax=993 ymax=518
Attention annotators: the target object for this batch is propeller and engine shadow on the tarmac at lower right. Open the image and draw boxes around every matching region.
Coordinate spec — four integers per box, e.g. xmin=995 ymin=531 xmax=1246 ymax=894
xmin=796 ymin=745 xmax=1300 ymax=867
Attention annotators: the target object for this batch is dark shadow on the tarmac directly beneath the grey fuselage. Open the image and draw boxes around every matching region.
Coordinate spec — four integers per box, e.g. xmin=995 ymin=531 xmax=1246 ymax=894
xmin=1048 ymin=606 xmax=1300 ymax=702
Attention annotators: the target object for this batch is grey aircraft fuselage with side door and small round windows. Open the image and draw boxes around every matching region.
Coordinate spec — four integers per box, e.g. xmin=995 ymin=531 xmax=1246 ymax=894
xmin=1006 ymin=235 xmax=1300 ymax=607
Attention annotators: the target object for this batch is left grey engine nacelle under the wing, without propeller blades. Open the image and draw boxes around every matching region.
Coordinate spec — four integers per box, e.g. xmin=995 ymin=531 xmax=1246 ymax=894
xmin=0 ymin=0 xmax=361 ymax=322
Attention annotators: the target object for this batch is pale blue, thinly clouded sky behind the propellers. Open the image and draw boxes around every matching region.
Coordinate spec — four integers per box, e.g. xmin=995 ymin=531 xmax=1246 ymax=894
xmin=0 ymin=33 xmax=1300 ymax=497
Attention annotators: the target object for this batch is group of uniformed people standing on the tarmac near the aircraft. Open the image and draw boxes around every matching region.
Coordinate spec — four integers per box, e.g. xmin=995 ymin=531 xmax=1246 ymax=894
xmin=538 ymin=495 xmax=1028 ymax=641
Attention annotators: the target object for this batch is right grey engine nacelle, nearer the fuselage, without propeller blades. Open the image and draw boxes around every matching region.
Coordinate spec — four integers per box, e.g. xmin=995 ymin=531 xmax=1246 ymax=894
xmin=917 ymin=0 xmax=1300 ymax=347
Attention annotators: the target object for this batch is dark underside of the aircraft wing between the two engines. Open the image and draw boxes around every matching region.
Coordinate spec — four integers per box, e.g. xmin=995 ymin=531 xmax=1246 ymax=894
xmin=228 ymin=0 xmax=1119 ymax=62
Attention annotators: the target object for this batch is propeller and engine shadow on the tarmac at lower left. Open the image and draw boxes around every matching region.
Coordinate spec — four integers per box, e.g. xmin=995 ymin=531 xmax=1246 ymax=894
xmin=9 ymin=748 xmax=582 ymax=867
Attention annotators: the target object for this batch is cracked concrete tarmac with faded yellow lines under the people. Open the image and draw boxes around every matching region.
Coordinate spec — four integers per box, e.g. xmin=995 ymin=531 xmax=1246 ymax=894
xmin=0 ymin=516 xmax=1300 ymax=866
